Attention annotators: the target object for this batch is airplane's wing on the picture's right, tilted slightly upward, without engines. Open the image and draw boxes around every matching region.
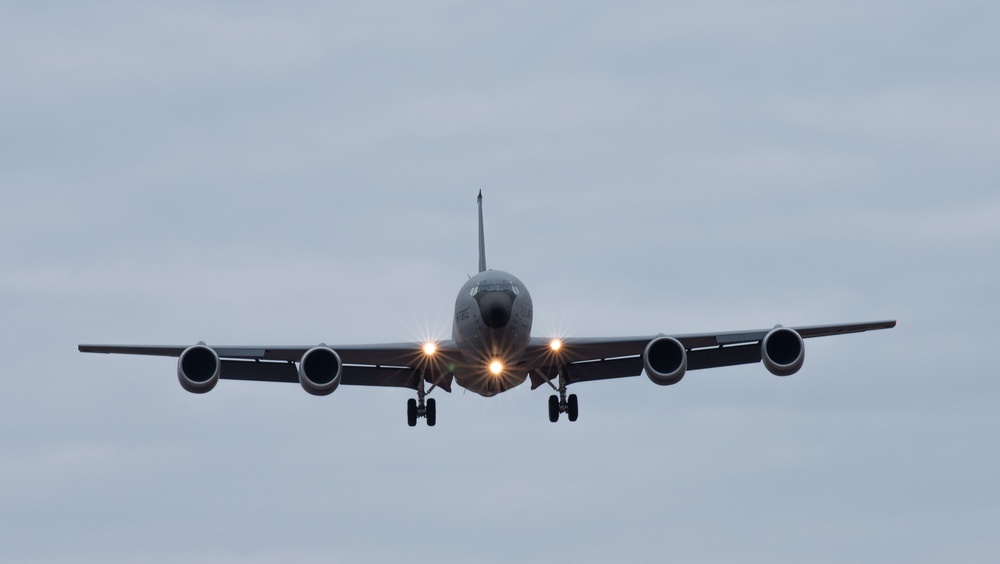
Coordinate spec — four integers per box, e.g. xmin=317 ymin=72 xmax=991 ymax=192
xmin=525 ymin=321 xmax=896 ymax=389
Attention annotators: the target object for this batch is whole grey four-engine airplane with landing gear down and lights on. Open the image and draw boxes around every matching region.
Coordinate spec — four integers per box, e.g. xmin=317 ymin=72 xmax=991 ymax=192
xmin=79 ymin=190 xmax=896 ymax=427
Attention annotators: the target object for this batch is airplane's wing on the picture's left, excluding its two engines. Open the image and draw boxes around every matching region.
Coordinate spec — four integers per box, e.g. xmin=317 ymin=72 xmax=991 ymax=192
xmin=78 ymin=341 xmax=461 ymax=392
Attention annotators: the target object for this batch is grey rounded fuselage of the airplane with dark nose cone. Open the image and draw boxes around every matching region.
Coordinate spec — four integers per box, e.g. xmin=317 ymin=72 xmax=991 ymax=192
xmin=452 ymin=270 xmax=534 ymax=396
